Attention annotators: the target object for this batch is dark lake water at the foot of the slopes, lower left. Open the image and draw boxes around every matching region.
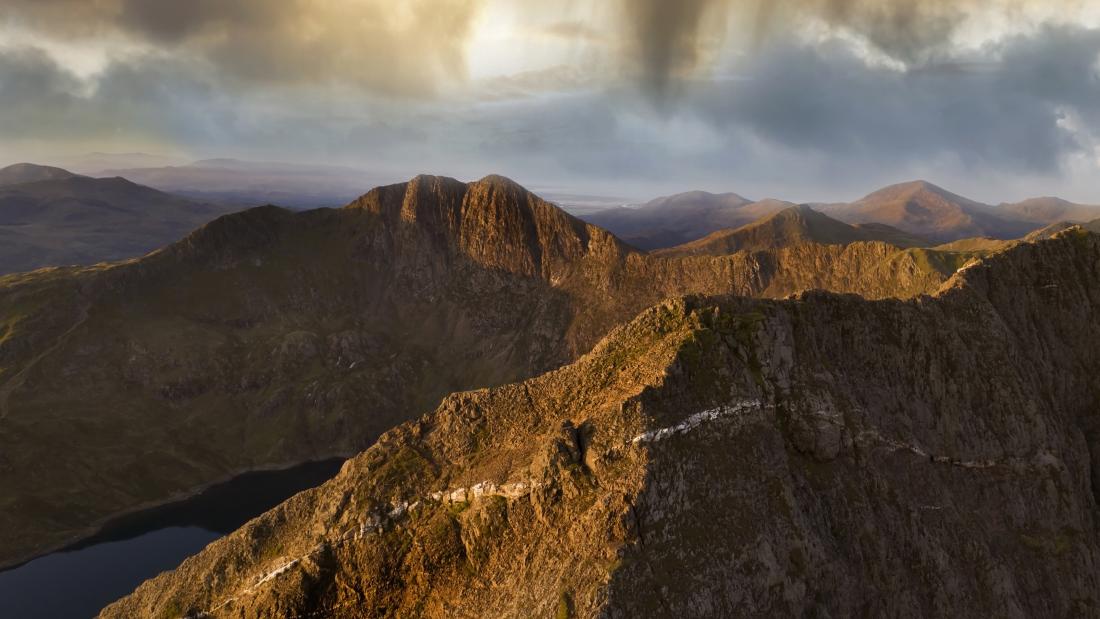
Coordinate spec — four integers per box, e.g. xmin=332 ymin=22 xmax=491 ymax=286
xmin=0 ymin=460 xmax=343 ymax=619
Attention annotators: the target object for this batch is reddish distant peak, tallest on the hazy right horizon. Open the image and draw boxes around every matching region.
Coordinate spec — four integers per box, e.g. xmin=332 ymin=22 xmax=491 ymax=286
xmin=818 ymin=180 xmax=1035 ymax=243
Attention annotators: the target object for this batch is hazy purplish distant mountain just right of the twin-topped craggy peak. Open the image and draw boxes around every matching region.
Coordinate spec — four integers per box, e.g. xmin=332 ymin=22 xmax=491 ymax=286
xmin=583 ymin=191 xmax=791 ymax=250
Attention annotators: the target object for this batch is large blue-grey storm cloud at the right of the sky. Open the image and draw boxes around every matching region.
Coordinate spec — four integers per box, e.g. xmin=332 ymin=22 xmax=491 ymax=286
xmin=690 ymin=27 xmax=1100 ymax=173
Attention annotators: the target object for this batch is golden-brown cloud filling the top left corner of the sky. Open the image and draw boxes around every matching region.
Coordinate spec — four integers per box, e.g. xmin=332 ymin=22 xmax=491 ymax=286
xmin=0 ymin=0 xmax=481 ymax=97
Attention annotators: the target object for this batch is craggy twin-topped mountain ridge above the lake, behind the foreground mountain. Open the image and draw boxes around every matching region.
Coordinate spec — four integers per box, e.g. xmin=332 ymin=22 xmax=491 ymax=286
xmin=0 ymin=177 xmax=1051 ymax=565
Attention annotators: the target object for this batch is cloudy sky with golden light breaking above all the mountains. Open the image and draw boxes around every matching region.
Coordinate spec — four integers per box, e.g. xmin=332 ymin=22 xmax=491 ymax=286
xmin=0 ymin=0 xmax=1100 ymax=203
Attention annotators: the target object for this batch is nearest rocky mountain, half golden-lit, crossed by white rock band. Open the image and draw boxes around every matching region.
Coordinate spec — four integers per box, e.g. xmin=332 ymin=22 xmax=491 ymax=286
xmin=100 ymin=230 xmax=1100 ymax=618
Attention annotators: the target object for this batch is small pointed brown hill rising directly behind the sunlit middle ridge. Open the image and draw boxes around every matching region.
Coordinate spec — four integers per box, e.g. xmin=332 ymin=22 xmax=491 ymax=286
xmin=655 ymin=206 xmax=930 ymax=256
